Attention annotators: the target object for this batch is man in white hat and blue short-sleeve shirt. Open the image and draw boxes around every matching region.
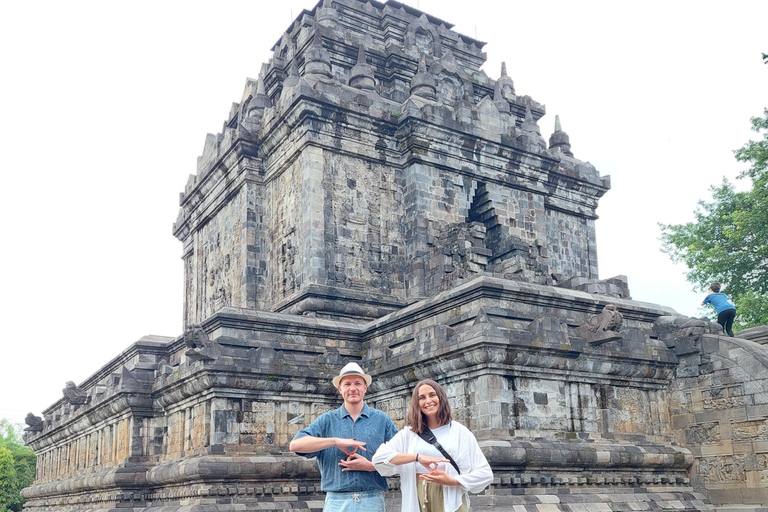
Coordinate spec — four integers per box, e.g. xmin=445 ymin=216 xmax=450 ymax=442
xmin=290 ymin=363 xmax=397 ymax=512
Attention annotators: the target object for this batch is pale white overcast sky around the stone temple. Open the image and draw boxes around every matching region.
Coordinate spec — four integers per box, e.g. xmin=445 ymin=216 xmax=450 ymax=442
xmin=0 ymin=0 xmax=768 ymax=422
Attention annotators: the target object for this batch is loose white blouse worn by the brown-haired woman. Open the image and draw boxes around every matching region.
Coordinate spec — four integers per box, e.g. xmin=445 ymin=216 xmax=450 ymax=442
xmin=372 ymin=421 xmax=493 ymax=512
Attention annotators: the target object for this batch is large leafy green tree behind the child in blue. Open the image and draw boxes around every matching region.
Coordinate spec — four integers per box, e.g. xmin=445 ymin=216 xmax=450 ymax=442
xmin=660 ymin=54 xmax=768 ymax=329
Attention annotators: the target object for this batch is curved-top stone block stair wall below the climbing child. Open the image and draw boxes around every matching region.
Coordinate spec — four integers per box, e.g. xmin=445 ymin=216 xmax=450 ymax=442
xmin=670 ymin=326 xmax=768 ymax=505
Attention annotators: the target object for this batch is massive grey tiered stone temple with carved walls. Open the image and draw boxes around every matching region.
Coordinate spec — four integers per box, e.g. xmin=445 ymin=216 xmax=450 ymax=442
xmin=18 ymin=0 xmax=768 ymax=512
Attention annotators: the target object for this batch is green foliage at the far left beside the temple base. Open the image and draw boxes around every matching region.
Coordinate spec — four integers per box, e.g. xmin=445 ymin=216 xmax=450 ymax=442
xmin=0 ymin=419 xmax=36 ymax=512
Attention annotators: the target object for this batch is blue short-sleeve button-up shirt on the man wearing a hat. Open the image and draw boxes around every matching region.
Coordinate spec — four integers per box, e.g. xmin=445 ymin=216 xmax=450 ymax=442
xmin=294 ymin=405 xmax=397 ymax=492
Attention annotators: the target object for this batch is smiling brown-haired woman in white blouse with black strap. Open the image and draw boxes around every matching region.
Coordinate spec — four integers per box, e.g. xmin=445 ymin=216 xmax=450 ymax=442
xmin=372 ymin=380 xmax=493 ymax=512
